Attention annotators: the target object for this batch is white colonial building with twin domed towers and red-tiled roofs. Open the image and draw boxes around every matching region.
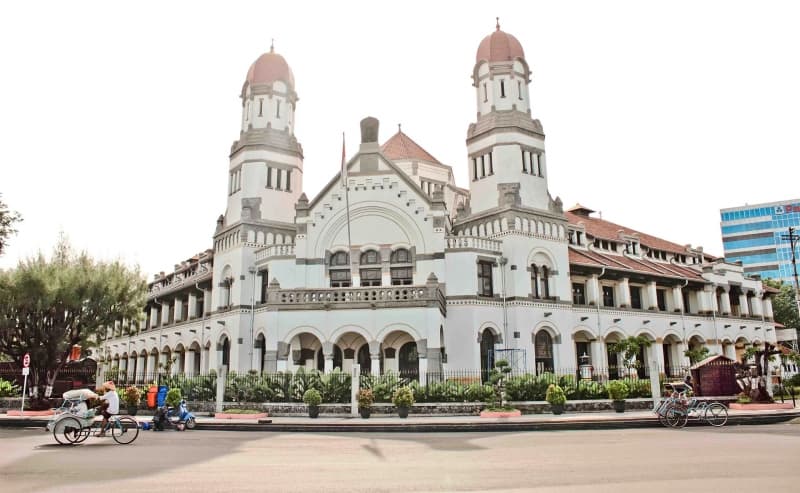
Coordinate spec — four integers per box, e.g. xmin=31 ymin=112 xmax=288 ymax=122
xmin=100 ymin=26 xmax=776 ymax=379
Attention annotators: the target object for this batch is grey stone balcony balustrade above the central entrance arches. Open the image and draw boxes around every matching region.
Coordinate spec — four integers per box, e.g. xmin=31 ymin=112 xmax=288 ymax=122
xmin=266 ymin=282 xmax=446 ymax=316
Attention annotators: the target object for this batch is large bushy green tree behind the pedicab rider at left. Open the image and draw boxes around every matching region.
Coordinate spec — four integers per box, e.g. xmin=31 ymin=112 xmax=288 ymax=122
xmin=0 ymin=238 xmax=147 ymax=404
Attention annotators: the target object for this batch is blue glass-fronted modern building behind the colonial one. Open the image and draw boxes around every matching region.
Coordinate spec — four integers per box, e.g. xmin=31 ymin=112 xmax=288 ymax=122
xmin=720 ymin=199 xmax=800 ymax=283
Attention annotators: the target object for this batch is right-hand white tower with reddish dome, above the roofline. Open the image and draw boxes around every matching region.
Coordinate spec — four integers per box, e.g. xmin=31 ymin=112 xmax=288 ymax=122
xmin=467 ymin=20 xmax=554 ymax=213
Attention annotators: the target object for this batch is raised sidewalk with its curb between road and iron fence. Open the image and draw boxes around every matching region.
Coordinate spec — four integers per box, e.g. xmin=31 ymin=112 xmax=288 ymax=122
xmin=0 ymin=408 xmax=800 ymax=433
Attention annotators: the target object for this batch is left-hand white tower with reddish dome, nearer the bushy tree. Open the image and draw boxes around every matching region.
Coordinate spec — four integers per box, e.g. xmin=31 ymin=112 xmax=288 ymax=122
xmin=210 ymin=47 xmax=303 ymax=359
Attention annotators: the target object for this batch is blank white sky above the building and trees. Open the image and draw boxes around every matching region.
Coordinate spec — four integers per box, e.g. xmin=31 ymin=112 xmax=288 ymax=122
xmin=0 ymin=0 xmax=800 ymax=278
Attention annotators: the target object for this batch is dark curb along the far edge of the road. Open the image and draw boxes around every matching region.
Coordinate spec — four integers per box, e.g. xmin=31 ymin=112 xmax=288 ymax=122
xmin=0 ymin=412 xmax=800 ymax=433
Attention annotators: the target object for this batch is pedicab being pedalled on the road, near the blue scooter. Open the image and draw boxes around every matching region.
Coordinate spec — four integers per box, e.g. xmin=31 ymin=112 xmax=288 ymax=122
xmin=46 ymin=399 xmax=139 ymax=445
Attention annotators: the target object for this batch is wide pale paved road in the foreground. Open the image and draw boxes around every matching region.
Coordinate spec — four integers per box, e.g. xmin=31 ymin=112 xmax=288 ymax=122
xmin=0 ymin=424 xmax=800 ymax=493
